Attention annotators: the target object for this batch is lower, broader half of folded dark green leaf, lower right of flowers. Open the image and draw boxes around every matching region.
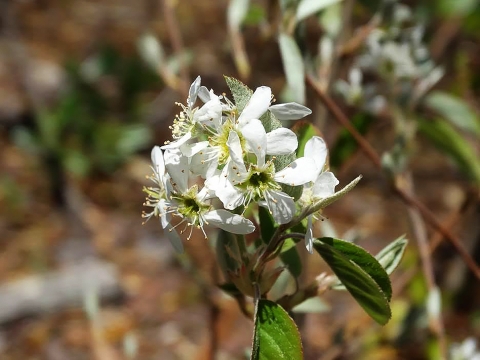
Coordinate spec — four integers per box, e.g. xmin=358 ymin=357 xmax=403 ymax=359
xmin=313 ymin=240 xmax=391 ymax=325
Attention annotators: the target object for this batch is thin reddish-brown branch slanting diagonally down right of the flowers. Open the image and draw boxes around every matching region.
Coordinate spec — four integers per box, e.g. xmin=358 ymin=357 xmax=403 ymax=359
xmin=306 ymin=75 xmax=480 ymax=279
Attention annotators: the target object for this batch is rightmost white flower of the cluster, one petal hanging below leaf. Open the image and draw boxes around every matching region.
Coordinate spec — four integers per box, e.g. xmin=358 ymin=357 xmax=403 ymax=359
xmin=302 ymin=136 xmax=339 ymax=253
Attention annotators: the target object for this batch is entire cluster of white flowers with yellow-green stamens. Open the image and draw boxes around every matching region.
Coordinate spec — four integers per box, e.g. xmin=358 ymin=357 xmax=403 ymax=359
xmin=143 ymin=77 xmax=338 ymax=252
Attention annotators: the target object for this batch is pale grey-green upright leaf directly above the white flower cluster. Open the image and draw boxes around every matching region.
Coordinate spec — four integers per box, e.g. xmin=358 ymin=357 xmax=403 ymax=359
xmin=278 ymin=33 xmax=305 ymax=104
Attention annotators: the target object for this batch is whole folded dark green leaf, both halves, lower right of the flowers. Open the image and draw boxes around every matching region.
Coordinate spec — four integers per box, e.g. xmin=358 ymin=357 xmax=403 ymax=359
xmin=313 ymin=238 xmax=391 ymax=325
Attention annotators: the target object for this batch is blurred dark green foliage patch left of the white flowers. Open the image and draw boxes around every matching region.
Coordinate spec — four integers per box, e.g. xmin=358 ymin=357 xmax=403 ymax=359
xmin=13 ymin=47 xmax=158 ymax=177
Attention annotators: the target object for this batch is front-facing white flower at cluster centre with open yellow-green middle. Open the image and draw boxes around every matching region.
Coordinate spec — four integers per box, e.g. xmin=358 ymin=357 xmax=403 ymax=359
xmin=211 ymin=124 xmax=316 ymax=224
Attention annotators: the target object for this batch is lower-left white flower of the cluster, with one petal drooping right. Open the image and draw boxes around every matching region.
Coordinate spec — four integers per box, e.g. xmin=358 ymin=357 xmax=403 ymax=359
xmin=144 ymin=147 xmax=255 ymax=252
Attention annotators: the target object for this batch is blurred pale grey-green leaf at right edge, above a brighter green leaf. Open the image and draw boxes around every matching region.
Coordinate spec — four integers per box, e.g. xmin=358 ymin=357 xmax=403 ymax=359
xmin=425 ymin=91 xmax=480 ymax=136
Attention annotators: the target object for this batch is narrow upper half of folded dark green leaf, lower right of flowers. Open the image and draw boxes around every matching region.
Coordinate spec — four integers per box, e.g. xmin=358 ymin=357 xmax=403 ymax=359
xmin=318 ymin=237 xmax=392 ymax=301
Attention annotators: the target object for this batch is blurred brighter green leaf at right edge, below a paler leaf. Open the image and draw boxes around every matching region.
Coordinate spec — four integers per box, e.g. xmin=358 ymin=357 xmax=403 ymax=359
xmin=418 ymin=120 xmax=480 ymax=184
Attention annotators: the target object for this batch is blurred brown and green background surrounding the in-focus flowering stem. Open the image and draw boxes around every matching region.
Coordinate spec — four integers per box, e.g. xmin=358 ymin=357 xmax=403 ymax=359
xmin=0 ymin=0 xmax=480 ymax=360
